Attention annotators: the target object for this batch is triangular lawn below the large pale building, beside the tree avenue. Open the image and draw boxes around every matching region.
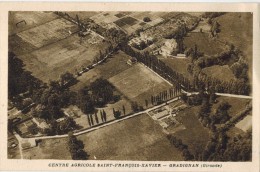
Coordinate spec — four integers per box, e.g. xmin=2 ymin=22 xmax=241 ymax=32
xmin=161 ymin=58 xmax=192 ymax=78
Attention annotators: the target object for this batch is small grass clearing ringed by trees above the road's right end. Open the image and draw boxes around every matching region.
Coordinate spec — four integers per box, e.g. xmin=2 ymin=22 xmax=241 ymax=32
xmin=202 ymin=65 xmax=236 ymax=82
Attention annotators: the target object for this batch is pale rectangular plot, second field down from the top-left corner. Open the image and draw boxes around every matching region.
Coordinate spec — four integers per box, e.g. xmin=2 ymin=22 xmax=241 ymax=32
xmin=17 ymin=19 xmax=78 ymax=48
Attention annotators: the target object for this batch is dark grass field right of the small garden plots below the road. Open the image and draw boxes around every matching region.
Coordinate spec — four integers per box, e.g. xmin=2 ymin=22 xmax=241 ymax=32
xmin=174 ymin=106 xmax=210 ymax=154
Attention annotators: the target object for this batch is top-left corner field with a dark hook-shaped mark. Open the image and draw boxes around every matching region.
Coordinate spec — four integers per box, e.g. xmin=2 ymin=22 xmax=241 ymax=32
xmin=8 ymin=11 xmax=58 ymax=35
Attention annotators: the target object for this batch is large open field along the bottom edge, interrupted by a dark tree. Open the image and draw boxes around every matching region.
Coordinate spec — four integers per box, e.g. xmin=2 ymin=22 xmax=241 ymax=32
xmin=23 ymin=114 xmax=183 ymax=161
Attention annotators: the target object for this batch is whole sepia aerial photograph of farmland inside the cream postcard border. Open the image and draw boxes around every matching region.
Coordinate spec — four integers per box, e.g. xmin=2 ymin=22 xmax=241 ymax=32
xmin=6 ymin=11 xmax=253 ymax=162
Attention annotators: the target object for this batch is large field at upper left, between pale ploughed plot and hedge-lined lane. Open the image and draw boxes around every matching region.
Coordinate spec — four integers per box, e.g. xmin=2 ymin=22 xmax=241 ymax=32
xmin=19 ymin=35 xmax=108 ymax=82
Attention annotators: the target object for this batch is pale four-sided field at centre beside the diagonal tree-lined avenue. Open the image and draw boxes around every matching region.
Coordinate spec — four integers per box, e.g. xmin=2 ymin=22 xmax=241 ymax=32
xmin=109 ymin=63 xmax=174 ymax=104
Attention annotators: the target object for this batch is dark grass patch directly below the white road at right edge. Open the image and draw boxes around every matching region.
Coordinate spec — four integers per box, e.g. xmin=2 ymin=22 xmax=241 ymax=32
xmin=211 ymin=96 xmax=250 ymax=116
